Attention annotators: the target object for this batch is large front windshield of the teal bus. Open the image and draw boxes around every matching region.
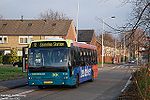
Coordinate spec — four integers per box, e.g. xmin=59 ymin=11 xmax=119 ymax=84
xmin=29 ymin=47 xmax=69 ymax=67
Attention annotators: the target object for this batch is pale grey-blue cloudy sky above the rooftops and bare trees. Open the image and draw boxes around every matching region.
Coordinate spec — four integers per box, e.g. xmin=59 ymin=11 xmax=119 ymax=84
xmin=0 ymin=0 xmax=131 ymax=34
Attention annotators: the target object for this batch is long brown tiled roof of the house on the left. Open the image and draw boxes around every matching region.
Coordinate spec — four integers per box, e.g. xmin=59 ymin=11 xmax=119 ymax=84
xmin=0 ymin=20 xmax=72 ymax=36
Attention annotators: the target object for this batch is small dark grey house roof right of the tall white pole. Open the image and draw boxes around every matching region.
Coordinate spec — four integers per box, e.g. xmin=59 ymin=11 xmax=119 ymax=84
xmin=78 ymin=30 xmax=94 ymax=42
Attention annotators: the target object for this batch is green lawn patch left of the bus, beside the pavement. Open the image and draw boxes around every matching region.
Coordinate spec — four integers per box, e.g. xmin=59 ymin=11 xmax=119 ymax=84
xmin=0 ymin=66 xmax=27 ymax=81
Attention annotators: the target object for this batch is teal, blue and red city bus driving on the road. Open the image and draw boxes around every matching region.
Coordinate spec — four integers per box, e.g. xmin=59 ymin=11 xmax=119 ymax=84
xmin=23 ymin=39 xmax=98 ymax=88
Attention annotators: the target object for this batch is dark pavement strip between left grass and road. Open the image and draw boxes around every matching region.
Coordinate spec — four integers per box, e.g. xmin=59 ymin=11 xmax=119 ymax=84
xmin=0 ymin=78 xmax=27 ymax=92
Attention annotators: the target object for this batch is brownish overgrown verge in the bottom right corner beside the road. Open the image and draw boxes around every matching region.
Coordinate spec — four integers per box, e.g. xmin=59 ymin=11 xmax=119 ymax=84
xmin=118 ymin=65 xmax=150 ymax=100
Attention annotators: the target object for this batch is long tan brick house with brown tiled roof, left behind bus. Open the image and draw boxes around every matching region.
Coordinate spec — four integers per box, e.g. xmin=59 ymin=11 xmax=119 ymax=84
xmin=0 ymin=20 xmax=76 ymax=56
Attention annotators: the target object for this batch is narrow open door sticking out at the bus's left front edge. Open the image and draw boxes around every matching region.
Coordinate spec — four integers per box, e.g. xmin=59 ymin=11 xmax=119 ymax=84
xmin=22 ymin=47 xmax=28 ymax=72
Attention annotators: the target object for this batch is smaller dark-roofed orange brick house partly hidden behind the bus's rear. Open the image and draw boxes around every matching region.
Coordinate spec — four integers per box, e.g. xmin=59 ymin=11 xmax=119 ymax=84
xmin=78 ymin=30 xmax=102 ymax=62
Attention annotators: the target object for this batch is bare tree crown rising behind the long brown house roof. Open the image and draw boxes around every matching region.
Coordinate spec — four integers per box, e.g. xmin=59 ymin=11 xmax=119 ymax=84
xmin=40 ymin=9 xmax=69 ymax=20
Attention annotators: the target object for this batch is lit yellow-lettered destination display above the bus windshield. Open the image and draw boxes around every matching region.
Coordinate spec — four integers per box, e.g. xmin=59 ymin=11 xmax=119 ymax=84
xmin=31 ymin=41 xmax=67 ymax=48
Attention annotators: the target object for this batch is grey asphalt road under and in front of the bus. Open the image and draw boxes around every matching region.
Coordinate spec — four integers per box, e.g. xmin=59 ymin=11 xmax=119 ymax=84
xmin=0 ymin=65 xmax=137 ymax=100
